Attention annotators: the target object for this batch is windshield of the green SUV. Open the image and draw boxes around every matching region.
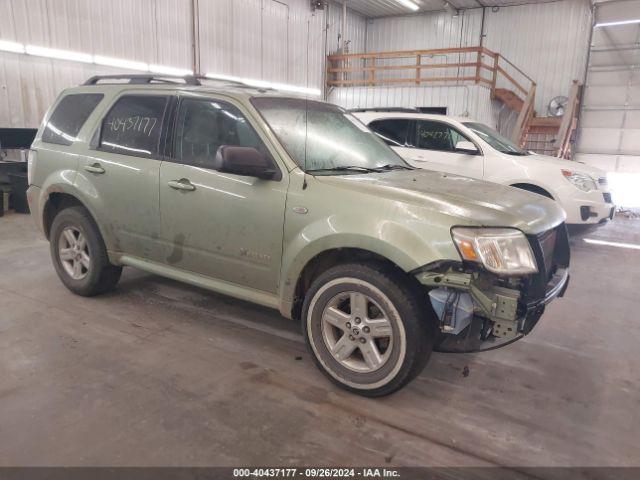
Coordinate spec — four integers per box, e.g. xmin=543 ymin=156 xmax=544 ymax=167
xmin=251 ymin=97 xmax=411 ymax=175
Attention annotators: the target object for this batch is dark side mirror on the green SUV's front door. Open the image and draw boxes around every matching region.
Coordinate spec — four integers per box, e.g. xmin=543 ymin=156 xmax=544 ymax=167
xmin=214 ymin=145 xmax=279 ymax=180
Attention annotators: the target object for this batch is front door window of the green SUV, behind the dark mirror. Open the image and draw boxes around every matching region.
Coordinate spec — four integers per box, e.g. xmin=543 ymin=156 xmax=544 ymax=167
xmin=174 ymin=99 xmax=269 ymax=168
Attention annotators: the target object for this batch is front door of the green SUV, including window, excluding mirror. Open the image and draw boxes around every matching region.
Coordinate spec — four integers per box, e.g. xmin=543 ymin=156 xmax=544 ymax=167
xmin=160 ymin=96 xmax=288 ymax=293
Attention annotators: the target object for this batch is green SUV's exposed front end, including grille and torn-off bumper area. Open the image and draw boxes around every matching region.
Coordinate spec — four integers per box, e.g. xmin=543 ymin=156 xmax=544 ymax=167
xmin=414 ymin=224 xmax=571 ymax=352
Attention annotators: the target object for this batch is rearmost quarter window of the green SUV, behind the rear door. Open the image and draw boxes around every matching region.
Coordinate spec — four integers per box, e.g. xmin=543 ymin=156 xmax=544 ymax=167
xmin=42 ymin=93 xmax=104 ymax=145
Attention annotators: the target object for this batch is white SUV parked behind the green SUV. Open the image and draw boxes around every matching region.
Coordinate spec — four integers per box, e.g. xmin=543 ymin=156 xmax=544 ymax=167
xmin=354 ymin=111 xmax=615 ymax=224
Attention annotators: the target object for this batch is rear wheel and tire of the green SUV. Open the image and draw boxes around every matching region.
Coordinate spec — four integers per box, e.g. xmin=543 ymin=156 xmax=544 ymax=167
xmin=49 ymin=207 xmax=122 ymax=297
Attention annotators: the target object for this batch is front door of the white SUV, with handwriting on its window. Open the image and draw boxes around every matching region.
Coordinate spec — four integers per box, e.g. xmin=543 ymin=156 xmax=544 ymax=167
xmin=405 ymin=120 xmax=484 ymax=179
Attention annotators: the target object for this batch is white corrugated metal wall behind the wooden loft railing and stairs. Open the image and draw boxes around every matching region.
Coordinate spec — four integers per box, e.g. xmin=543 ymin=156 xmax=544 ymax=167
xmin=330 ymin=0 xmax=591 ymax=127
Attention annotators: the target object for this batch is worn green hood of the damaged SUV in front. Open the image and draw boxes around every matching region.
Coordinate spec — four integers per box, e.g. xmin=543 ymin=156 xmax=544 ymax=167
xmin=316 ymin=170 xmax=565 ymax=234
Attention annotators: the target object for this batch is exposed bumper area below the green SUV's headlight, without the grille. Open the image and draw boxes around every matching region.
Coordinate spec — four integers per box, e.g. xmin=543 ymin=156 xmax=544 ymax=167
xmin=416 ymin=268 xmax=570 ymax=352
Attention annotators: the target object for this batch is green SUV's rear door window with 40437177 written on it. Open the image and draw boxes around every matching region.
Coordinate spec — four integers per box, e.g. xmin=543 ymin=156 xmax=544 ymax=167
xmin=100 ymin=95 xmax=167 ymax=157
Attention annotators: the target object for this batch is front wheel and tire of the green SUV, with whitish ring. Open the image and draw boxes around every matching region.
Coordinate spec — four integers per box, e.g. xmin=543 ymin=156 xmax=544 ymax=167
xmin=302 ymin=263 xmax=437 ymax=397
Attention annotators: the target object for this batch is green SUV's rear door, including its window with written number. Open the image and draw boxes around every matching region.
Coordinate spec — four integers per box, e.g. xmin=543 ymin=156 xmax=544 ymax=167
xmin=76 ymin=91 xmax=170 ymax=260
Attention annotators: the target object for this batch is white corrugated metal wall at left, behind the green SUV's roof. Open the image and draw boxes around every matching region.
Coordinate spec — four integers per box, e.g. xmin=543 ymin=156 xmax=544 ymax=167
xmin=0 ymin=0 xmax=325 ymax=127
